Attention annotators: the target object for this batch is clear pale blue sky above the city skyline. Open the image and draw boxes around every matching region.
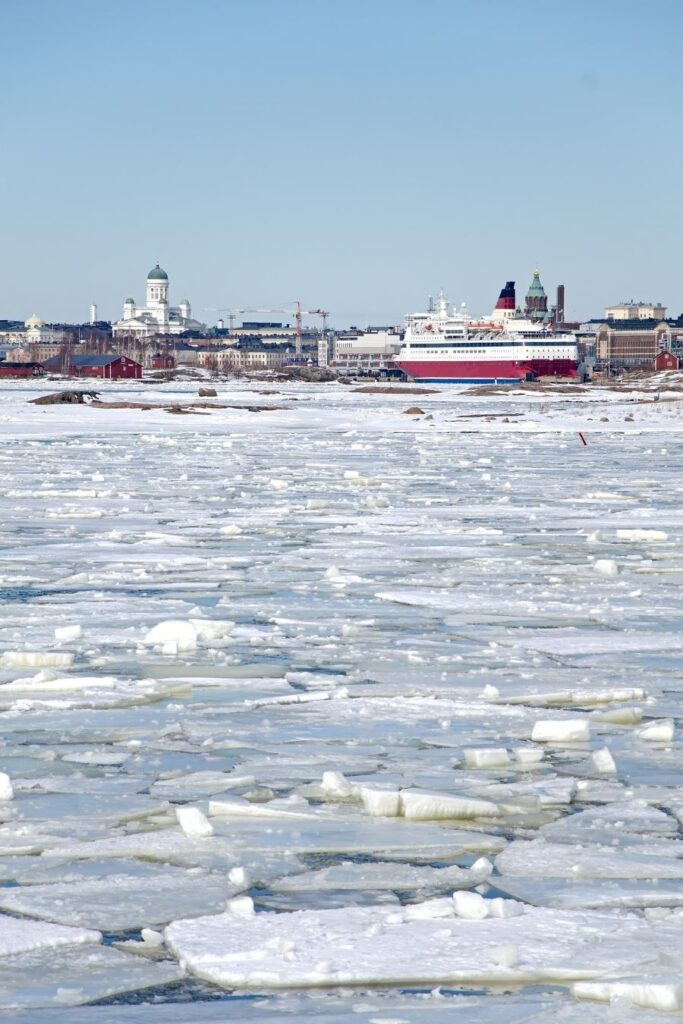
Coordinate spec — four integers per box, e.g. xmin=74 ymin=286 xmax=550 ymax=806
xmin=0 ymin=0 xmax=683 ymax=324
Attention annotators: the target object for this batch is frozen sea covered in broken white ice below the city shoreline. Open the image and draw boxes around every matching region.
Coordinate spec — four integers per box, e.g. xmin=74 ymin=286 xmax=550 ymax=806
xmin=0 ymin=378 xmax=683 ymax=1024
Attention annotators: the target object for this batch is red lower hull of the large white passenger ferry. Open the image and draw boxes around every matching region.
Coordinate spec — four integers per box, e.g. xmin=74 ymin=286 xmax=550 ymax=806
xmin=396 ymin=358 xmax=577 ymax=384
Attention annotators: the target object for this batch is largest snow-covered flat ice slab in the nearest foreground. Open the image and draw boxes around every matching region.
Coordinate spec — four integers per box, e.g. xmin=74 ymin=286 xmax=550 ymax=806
xmin=164 ymin=894 xmax=683 ymax=990
